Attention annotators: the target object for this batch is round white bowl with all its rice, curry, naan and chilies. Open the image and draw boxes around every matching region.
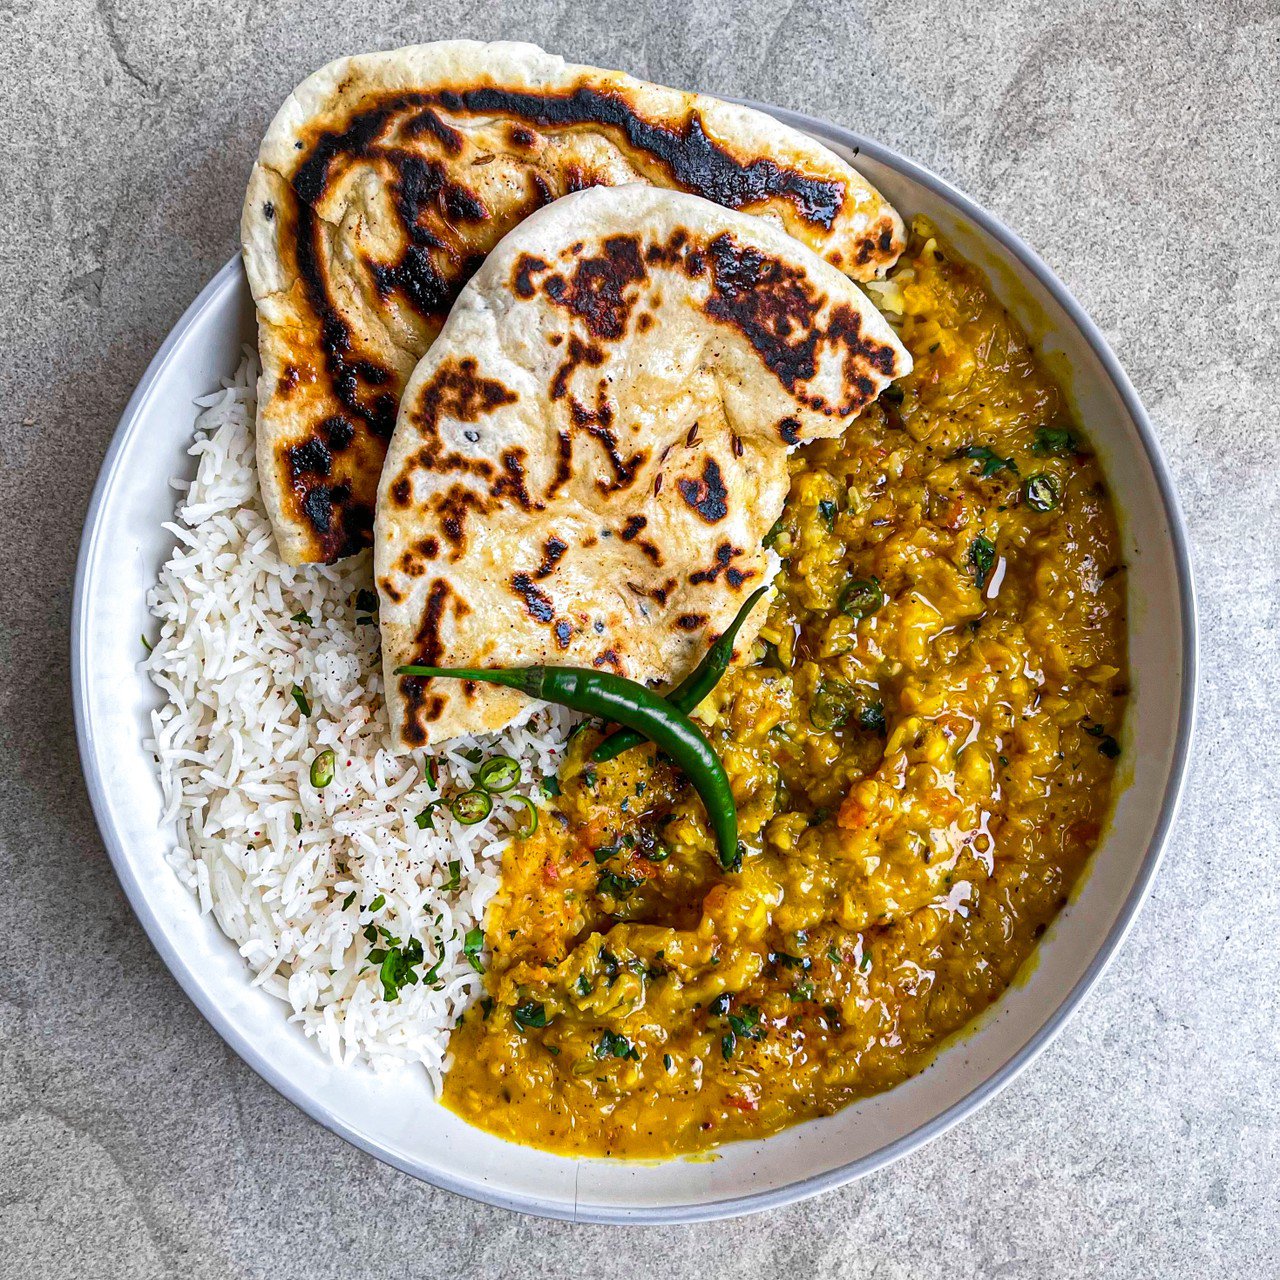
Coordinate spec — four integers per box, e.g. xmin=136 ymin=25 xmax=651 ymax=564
xmin=73 ymin=42 xmax=1196 ymax=1221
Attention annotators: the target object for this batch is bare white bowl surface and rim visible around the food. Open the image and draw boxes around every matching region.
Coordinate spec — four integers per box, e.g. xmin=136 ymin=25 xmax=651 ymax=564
xmin=72 ymin=109 xmax=1196 ymax=1222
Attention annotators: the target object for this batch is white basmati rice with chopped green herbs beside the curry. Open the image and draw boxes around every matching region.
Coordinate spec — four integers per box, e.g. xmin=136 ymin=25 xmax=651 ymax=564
xmin=143 ymin=352 xmax=573 ymax=1088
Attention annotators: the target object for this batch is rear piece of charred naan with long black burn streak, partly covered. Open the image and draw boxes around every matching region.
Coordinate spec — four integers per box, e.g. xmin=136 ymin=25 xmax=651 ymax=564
xmin=242 ymin=41 xmax=904 ymax=563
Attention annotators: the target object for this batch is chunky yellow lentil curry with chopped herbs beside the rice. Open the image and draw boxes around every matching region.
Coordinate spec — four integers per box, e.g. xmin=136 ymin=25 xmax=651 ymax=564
xmin=444 ymin=221 xmax=1126 ymax=1157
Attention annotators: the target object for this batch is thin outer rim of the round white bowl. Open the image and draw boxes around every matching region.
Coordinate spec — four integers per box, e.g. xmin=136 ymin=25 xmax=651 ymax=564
xmin=70 ymin=107 xmax=1199 ymax=1225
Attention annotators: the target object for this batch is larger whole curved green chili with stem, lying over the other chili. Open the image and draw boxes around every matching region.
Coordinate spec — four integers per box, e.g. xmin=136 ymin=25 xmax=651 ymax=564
xmin=396 ymin=664 xmax=742 ymax=870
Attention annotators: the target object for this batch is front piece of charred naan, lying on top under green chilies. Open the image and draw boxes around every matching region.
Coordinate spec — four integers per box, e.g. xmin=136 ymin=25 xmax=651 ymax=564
xmin=374 ymin=186 xmax=910 ymax=749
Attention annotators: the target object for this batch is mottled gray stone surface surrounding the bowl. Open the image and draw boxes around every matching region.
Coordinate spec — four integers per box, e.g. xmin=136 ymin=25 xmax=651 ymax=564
xmin=0 ymin=0 xmax=1280 ymax=1280
